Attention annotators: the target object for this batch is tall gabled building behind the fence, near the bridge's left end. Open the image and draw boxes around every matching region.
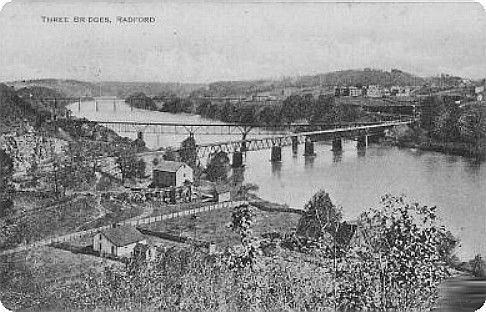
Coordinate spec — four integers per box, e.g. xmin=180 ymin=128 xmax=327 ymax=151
xmin=153 ymin=161 xmax=194 ymax=187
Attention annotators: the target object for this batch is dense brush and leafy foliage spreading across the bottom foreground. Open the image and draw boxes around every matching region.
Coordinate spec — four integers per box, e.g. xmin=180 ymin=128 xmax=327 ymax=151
xmin=0 ymin=191 xmax=456 ymax=311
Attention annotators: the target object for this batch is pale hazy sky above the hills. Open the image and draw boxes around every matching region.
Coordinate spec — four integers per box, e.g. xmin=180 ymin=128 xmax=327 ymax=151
xmin=0 ymin=0 xmax=486 ymax=83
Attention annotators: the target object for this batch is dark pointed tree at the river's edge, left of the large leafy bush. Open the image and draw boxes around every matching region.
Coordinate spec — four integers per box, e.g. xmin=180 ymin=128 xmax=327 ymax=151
xmin=296 ymin=190 xmax=342 ymax=239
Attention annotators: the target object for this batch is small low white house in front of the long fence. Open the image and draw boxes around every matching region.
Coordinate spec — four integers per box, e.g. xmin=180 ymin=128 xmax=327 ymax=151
xmin=93 ymin=225 xmax=147 ymax=257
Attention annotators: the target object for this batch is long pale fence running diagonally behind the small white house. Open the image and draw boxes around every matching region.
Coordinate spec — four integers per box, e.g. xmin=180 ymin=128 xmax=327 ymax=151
xmin=0 ymin=201 xmax=248 ymax=256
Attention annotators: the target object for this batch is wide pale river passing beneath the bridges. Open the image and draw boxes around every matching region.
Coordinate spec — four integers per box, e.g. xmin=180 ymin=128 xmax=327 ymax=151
xmin=70 ymin=102 xmax=486 ymax=260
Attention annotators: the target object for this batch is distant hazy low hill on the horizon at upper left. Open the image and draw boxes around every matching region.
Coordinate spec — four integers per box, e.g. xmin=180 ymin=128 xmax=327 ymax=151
xmin=6 ymin=79 xmax=204 ymax=98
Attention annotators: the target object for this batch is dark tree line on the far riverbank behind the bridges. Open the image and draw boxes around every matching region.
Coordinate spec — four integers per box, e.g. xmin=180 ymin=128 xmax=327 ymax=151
xmin=126 ymin=93 xmax=376 ymax=124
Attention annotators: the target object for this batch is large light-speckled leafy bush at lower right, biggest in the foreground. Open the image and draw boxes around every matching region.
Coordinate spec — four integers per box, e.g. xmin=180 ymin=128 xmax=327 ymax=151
xmin=337 ymin=195 xmax=456 ymax=311
